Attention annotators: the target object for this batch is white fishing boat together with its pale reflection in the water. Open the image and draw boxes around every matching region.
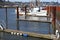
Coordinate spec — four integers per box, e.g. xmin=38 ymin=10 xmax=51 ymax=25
xmin=15 ymin=7 xmax=47 ymax=20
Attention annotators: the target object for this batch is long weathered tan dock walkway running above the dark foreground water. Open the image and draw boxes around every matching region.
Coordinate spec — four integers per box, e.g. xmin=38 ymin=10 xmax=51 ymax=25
xmin=0 ymin=29 xmax=56 ymax=39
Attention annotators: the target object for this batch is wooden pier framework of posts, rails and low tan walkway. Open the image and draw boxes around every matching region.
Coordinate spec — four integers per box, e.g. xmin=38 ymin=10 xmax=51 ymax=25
xmin=0 ymin=6 xmax=56 ymax=39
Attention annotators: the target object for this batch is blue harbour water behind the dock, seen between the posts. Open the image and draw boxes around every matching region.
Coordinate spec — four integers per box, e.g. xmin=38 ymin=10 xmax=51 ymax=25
xmin=0 ymin=8 xmax=53 ymax=40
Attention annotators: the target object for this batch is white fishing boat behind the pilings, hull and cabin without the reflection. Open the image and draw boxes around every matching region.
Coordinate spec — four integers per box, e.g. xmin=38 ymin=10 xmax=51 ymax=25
xmin=15 ymin=7 xmax=47 ymax=16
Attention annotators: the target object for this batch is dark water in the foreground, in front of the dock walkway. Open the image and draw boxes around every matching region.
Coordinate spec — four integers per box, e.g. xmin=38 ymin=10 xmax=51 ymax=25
xmin=0 ymin=32 xmax=48 ymax=40
